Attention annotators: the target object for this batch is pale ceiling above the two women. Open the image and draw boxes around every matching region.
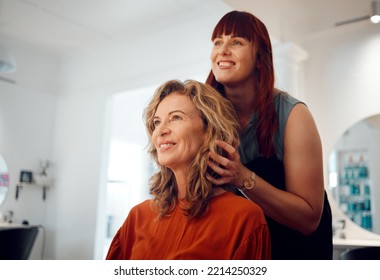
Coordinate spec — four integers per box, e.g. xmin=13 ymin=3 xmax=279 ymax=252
xmin=0 ymin=0 xmax=371 ymax=57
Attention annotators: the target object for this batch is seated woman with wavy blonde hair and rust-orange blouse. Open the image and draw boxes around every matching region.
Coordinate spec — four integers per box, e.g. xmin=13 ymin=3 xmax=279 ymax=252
xmin=107 ymin=80 xmax=271 ymax=260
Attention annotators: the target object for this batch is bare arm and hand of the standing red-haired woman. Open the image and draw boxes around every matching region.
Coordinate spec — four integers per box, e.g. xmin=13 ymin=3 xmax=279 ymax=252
xmin=210 ymin=104 xmax=324 ymax=234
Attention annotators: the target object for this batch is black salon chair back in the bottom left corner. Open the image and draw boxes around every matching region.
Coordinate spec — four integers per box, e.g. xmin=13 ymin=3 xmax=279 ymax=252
xmin=0 ymin=226 xmax=38 ymax=260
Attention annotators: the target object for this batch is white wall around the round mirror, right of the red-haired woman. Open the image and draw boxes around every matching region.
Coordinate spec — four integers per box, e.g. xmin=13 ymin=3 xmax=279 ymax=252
xmin=298 ymin=21 xmax=380 ymax=239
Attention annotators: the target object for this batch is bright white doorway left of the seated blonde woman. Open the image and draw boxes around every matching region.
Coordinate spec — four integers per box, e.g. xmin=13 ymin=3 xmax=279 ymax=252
xmin=103 ymin=86 xmax=156 ymax=259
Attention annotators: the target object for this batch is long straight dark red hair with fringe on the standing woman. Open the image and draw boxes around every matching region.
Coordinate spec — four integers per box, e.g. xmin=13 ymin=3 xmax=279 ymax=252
xmin=206 ymin=11 xmax=278 ymax=157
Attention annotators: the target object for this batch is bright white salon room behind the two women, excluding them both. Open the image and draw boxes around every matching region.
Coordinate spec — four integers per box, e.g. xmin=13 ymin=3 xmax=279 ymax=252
xmin=0 ymin=0 xmax=380 ymax=260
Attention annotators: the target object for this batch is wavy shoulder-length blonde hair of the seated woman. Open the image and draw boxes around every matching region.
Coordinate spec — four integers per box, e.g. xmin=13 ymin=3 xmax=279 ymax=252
xmin=144 ymin=80 xmax=239 ymax=218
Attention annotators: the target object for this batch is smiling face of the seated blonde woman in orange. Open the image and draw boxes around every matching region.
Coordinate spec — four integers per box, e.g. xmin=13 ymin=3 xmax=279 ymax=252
xmin=152 ymin=92 xmax=206 ymax=172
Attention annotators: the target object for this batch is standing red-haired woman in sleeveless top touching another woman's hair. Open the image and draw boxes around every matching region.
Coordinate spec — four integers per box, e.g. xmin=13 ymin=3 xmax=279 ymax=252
xmin=207 ymin=11 xmax=332 ymax=259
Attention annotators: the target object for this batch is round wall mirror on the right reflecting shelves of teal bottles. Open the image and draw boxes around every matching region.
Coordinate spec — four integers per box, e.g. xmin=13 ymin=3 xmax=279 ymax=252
xmin=329 ymin=115 xmax=380 ymax=233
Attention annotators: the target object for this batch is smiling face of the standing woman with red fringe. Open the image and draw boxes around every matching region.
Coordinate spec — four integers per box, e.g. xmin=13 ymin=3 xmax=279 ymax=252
xmin=210 ymin=35 xmax=256 ymax=86
